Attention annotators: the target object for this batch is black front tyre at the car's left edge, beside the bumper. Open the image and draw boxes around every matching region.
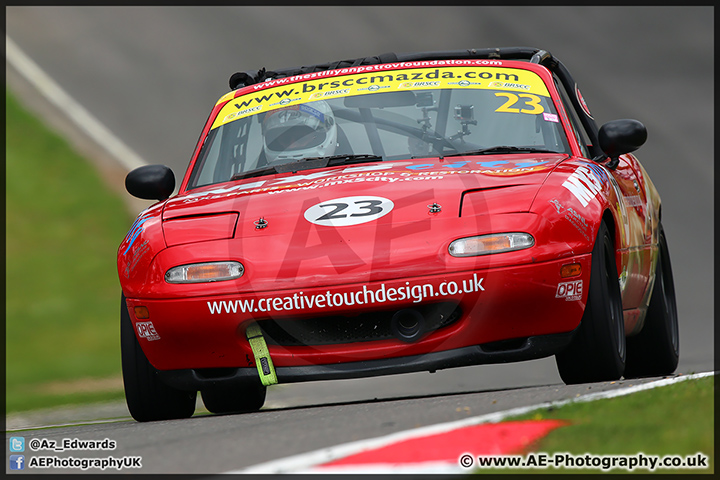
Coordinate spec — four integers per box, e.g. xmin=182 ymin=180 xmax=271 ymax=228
xmin=120 ymin=295 xmax=197 ymax=422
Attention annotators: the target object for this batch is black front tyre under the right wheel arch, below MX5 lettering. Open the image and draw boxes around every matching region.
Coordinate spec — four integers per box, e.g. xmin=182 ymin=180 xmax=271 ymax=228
xmin=555 ymin=221 xmax=627 ymax=385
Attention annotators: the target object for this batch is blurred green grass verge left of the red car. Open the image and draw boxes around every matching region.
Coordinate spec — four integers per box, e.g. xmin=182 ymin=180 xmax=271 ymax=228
xmin=5 ymin=91 xmax=132 ymax=412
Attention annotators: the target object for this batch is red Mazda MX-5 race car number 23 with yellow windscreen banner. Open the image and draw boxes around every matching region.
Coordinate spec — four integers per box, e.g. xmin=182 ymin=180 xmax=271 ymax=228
xmin=117 ymin=47 xmax=678 ymax=421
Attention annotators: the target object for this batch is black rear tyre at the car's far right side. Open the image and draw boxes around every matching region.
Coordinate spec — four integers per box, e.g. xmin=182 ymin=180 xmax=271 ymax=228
xmin=625 ymin=225 xmax=680 ymax=378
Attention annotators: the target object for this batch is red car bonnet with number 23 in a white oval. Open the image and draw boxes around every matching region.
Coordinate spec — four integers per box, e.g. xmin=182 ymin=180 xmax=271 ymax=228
xmin=163 ymin=155 xmax=567 ymax=291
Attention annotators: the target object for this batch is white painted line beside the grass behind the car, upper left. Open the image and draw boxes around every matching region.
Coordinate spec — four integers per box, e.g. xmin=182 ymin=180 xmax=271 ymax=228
xmin=5 ymin=34 xmax=147 ymax=171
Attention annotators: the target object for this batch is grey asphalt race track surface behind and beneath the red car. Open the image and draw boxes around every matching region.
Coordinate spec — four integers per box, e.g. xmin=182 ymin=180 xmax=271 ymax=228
xmin=6 ymin=7 xmax=715 ymax=473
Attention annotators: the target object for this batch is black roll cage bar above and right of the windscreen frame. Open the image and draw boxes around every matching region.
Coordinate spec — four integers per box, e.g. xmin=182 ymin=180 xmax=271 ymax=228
xmin=229 ymin=47 xmax=608 ymax=162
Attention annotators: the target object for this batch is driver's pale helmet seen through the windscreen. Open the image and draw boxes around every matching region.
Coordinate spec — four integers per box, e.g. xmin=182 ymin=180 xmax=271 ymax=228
xmin=262 ymin=100 xmax=337 ymax=164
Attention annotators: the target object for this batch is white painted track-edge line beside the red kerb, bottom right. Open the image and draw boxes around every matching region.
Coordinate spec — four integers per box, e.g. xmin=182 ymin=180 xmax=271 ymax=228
xmin=235 ymin=372 xmax=715 ymax=474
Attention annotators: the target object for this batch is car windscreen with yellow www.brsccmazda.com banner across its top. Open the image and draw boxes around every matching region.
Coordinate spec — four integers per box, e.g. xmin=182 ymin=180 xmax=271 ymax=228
xmin=189 ymin=67 xmax=570 ymax=188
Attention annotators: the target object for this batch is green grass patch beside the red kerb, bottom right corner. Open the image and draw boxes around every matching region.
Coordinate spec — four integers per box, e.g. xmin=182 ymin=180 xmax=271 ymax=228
xmin=478 ymin=377 xmax=714 ymax=474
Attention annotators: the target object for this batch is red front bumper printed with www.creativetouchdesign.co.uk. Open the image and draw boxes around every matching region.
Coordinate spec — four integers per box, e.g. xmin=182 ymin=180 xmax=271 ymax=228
xmin=122 ymin=254 xmax=591 ymax=374
